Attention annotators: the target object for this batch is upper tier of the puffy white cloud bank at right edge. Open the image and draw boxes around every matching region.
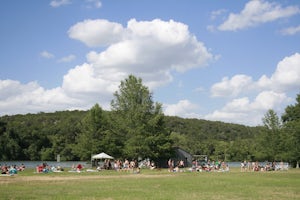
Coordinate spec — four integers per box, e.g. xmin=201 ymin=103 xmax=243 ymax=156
xmin=210 ymin=53 xmax=300 ymax=97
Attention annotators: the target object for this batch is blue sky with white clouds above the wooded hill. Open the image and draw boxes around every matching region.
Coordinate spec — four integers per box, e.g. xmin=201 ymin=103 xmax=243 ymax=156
xmin=0 ymin=0 xmax=300 ymax=126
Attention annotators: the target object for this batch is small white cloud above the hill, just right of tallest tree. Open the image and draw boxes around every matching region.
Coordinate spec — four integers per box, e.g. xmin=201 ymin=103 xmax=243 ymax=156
xmin=164 ymin=99 xmax=199 ymax=118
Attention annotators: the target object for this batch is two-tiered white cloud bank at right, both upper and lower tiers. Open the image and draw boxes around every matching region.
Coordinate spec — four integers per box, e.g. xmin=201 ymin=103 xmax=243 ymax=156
xmin=205 ymin=53 xmax=300 ymax=125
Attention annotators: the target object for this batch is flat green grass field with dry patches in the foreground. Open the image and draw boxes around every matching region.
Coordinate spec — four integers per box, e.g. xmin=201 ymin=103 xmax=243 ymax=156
xmin=0 ymin=169 xmax=300 ymax=200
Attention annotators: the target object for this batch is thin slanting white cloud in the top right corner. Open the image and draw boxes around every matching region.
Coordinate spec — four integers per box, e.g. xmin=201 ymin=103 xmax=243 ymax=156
xmin=218 ymin=0 xmax=300 ymax=31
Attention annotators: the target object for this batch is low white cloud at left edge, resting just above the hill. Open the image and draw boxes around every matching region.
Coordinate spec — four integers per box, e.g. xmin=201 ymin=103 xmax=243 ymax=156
xmin=0 ymin=80 xmax=84 ymax=115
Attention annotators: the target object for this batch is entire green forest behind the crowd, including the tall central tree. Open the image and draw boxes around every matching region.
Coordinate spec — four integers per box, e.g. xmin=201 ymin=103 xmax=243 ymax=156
xmin=0 ymin=75 xmax=300 ymax=166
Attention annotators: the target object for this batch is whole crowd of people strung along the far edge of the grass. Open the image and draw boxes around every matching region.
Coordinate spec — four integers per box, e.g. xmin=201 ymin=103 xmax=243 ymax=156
xmin=0 ymin=159 xmax=289 ymax=175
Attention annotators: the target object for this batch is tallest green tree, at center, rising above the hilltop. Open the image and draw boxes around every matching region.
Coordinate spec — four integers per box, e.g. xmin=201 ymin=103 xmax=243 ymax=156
xmin=111 ymin=75 xmax=172 ymax=160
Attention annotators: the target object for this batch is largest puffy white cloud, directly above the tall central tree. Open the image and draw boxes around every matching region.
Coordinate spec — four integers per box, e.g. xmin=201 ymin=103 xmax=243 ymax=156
xmin=68 ymin=19 xmax=213 ymax=89
